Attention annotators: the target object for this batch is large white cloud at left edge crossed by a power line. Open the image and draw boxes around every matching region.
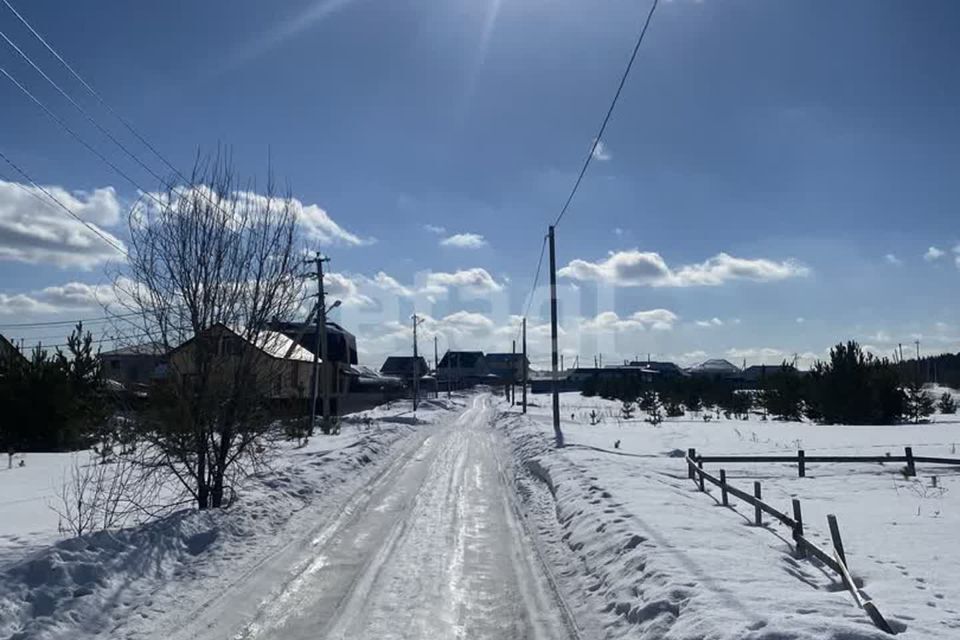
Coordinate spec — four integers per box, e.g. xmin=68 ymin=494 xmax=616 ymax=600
xmin=0 ymin=180 xmax=123 ymax=269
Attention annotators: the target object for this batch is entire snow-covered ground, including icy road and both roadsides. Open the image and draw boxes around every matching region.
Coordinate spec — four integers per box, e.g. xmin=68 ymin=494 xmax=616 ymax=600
xmin=0 ymin=392 xmax=960 ymax=640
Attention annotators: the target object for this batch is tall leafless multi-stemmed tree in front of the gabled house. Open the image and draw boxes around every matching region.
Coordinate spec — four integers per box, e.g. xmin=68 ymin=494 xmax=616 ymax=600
xmin=115 ymin=154 xmax=303 ymax=509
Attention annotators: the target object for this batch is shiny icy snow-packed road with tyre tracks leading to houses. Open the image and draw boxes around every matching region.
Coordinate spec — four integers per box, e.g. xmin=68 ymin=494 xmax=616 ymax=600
xmin=217 ymin=395 xmax=571 ymax=640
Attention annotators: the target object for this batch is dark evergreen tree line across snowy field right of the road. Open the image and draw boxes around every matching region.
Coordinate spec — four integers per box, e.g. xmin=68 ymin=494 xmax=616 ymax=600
xmin=583 ymin=341 xmax=956 ymax=424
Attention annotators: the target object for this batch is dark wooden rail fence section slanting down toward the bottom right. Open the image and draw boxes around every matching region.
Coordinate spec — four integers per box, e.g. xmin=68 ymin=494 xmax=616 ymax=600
xmin=686 ymin=456 xmax=894 ymax=635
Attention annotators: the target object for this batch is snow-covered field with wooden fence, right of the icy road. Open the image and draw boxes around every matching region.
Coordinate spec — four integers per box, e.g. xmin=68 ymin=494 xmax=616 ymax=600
xmin=500 ymin=394 xmax=960 ymax=640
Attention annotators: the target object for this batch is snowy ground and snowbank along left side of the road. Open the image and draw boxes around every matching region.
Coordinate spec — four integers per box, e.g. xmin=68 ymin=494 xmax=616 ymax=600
xmin=0 ymin=399 xmax=458 ymax=639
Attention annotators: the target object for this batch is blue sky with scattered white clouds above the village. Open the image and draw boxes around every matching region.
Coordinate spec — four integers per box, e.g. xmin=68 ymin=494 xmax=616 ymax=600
xmin=0 ymin=0 xmax=960 ymax=364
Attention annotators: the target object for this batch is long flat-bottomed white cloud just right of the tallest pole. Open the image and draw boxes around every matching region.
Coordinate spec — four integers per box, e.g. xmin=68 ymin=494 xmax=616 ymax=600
xmin=559 ymin=249 xmax=810 ymax=287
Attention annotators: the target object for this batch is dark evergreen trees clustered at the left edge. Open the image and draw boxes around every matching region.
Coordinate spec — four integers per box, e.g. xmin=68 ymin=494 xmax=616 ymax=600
xmin=0 ymin=324 xmax=109 ymax=452
